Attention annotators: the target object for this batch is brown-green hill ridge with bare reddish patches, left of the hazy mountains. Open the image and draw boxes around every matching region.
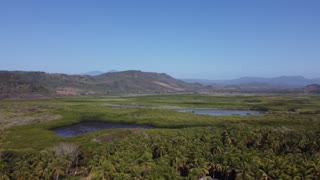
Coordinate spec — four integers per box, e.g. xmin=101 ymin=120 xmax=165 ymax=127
xmin=0 ymin=71 xmax=204 ymax=98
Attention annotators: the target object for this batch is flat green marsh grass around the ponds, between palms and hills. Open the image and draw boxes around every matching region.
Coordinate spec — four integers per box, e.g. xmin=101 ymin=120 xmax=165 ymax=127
xmin=0 ymin=94 xmax=320 ymax=150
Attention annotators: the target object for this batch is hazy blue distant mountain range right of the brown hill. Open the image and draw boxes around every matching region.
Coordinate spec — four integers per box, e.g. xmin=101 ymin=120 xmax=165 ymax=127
xmin=185 ymin=76 xmax=320 ymax=88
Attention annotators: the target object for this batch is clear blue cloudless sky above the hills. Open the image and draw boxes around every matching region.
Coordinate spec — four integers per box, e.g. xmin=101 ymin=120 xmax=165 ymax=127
xmin=0 ymin=0 xmax=320 ymax=79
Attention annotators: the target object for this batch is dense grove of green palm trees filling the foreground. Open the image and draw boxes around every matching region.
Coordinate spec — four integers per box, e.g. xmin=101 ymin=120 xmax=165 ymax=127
xmin=0 ymin=126 xmax=320 ymax=180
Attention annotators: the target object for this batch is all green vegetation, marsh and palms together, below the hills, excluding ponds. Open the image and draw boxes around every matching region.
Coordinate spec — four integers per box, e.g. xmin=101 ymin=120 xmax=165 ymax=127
xmin=0 ymin=94 xmax=320 ymax=179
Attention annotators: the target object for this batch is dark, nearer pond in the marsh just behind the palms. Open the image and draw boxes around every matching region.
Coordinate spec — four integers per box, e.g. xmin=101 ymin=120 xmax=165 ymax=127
xmin=52 ymin=121 xmax=154 ymax=137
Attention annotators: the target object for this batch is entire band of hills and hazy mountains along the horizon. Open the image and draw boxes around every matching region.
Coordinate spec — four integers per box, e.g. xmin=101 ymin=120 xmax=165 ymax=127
xmin=0 ymin=70 xmax=320 ymax=98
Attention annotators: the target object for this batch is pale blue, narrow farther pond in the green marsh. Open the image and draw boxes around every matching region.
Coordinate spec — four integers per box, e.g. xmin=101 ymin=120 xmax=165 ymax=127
xmin=176 ymin=109 xmax=260 ymax=116
